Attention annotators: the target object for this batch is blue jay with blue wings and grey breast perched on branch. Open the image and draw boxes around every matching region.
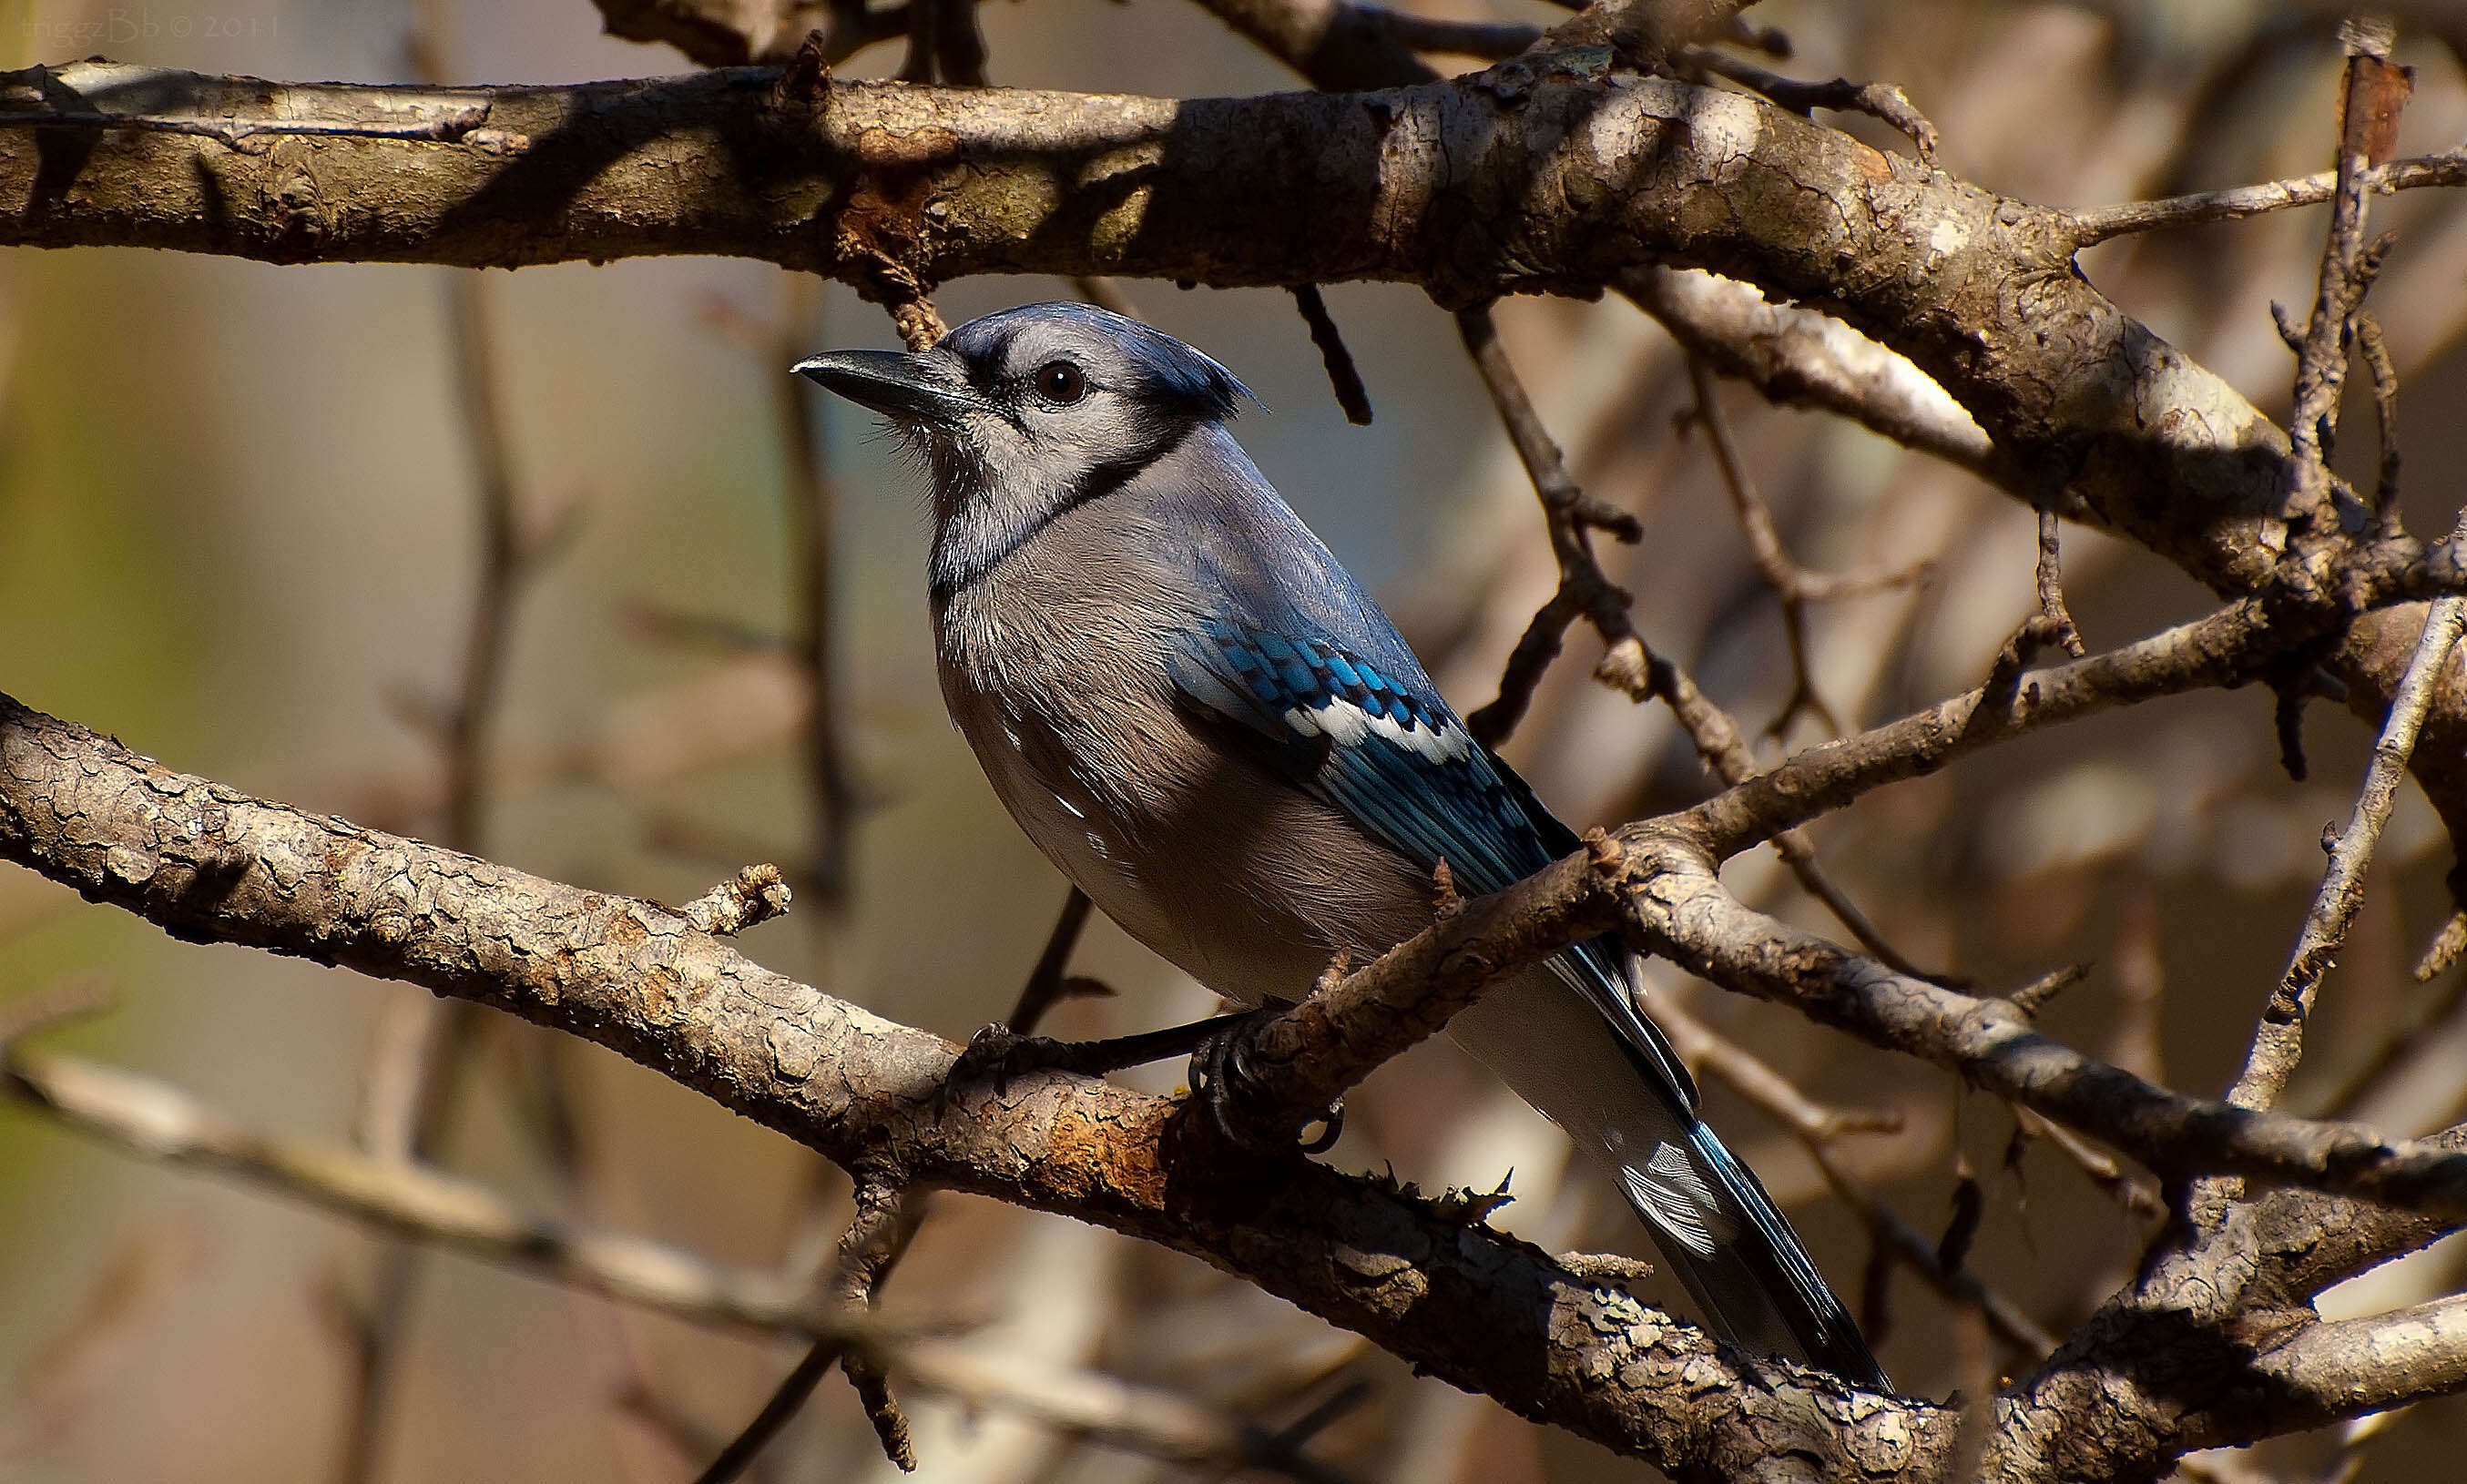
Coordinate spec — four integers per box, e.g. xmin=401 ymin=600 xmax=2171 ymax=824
xmin=797 ymin=303 xmax=1885 ymax=1387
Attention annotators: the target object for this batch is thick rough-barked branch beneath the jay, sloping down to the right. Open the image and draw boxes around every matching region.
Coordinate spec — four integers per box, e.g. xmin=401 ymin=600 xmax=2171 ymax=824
xmin=0 ymin=700 xmax=1942 ymax=1479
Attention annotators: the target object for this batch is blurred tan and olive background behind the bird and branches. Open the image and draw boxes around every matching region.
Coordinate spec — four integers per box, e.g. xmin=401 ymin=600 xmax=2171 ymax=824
xmin=0 ymin=0 xmax=2467 ymax=1484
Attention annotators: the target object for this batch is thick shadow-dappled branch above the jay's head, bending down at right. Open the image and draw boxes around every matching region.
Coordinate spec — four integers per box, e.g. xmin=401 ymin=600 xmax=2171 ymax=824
xmin=0 ymin=52 xmax=2467 ymax=852
